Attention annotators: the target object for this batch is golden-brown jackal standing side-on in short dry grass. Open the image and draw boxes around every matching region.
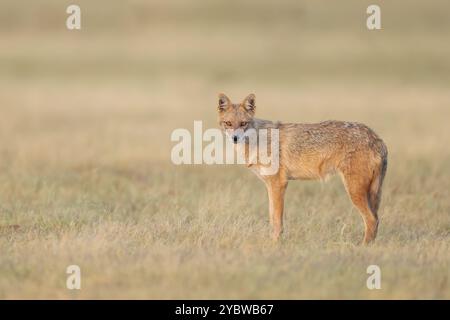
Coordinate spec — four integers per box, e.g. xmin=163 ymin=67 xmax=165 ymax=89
xmin=218 ymin=94 xmax=387 ymax=244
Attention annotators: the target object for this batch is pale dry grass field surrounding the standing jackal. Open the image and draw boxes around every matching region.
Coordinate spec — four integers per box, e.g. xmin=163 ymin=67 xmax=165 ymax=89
xmin=0 ymin=0 xmax=450 ymax=299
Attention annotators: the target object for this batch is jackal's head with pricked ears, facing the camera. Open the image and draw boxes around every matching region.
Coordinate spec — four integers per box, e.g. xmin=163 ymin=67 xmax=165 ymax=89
xmin=218 ymin=93 xmax=256 ymax=143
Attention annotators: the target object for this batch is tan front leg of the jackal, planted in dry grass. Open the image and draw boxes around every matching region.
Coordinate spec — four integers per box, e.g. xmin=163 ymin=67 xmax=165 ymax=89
xmin=266 ymin=179 xmax=287 ymax=240
